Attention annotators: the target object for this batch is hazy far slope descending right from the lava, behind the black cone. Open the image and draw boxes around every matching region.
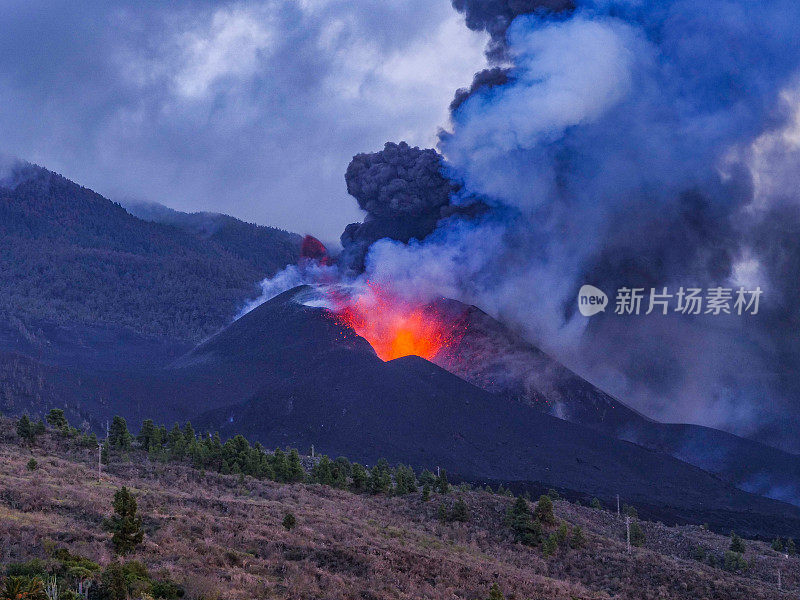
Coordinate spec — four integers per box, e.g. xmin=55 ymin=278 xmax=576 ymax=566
xmin=432 ymin=299 xmax=800 ymax=504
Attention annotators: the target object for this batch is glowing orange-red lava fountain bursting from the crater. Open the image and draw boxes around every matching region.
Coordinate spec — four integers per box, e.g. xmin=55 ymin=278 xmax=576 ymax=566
xmin=334 ymin=284 xmax=460 ymax=360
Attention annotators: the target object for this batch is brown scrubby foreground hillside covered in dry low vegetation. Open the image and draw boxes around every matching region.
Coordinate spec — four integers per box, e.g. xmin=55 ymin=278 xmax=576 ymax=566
xmin=0 ymin=419 xmax=800 ymax=600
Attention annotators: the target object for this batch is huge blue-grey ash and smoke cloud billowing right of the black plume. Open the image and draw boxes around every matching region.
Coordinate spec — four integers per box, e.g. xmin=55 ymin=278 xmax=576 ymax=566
xmin=354 ymin=0 xmax=800 ymax=450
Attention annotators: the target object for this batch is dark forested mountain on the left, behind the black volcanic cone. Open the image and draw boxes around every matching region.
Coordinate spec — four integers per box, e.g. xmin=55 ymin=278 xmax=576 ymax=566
xmin=0 ymin=162 xmax=300 ymax=354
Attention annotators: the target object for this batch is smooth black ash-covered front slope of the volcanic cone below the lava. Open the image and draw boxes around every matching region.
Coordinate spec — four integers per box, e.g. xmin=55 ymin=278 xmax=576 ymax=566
xmin=180 ymin=287 xmax=800 ymax=533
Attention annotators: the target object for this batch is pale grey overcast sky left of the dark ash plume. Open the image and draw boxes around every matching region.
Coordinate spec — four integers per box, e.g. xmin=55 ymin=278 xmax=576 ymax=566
xmin=0 ymin=0 xmax=486 ymax=240
